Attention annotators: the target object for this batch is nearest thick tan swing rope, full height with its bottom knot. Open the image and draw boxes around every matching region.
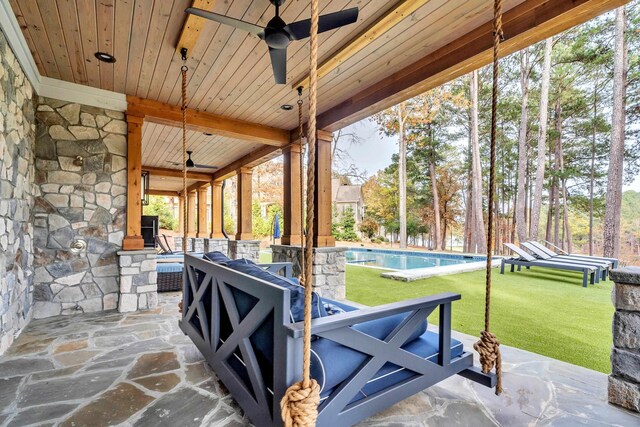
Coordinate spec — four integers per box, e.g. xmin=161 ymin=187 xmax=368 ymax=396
xmin=280 ymin=0 xmax=320 ymax=427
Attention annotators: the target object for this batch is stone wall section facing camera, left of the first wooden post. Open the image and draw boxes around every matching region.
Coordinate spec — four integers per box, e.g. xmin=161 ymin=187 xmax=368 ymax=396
xmin=33 ymin=97 xmax=127 ymax=318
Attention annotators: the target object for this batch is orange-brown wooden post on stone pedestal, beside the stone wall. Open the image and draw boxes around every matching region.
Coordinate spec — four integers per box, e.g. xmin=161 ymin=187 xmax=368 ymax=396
xmin=122 ymin=114 xmax=144 ymax=251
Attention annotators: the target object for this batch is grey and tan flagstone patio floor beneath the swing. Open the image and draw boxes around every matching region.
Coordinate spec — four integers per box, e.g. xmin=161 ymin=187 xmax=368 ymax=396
xmin=0 ymin=294 xmax=640 ymax=427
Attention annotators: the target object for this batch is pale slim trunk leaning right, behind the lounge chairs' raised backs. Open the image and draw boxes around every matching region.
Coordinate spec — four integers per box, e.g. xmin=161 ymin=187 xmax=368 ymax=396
xmin=529 ymin=37 xmax=553 ymax=240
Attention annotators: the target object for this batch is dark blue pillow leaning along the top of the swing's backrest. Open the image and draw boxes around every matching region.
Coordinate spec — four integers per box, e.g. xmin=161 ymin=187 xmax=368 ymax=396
xmin=226 ymin=259 xmax=327 ymax=322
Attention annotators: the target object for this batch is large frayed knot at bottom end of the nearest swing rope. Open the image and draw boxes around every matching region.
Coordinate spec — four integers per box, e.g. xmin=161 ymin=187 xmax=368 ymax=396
xmin=280 ymin=379 xmax=320 ymax=427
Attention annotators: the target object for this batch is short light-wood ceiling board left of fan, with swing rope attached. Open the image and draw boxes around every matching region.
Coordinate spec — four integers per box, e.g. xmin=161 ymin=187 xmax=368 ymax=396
xmin=135 ymin=0 xmax=175 ymax=97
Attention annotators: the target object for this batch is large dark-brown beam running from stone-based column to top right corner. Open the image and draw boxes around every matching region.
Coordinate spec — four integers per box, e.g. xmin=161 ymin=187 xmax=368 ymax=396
xmin=318 ymin=0 xmax=629 ymax=131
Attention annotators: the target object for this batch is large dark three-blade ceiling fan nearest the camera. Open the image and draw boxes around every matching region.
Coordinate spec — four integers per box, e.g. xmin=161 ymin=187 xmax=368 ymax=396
xmin=185 ymin=0 xmax=358 ymax=84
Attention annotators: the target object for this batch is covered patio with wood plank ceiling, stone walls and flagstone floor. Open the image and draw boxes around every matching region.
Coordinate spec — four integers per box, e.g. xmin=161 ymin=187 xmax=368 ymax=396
xmin=0 ymin=0 xmax=640 ymax=426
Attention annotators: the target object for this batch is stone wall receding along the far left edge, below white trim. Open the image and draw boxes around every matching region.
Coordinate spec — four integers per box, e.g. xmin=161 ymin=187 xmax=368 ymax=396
xmin=0 ymin=28 xmax=36 ymax=354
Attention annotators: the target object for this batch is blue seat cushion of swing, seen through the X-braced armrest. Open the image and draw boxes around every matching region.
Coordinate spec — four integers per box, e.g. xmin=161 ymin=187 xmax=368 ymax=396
xmin=311 ymin=299 xmax=463 ymax=400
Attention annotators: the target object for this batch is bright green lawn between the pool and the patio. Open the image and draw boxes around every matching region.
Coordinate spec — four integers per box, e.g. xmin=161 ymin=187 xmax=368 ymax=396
xmin=347 ymin=265 xmax=614 ymax=373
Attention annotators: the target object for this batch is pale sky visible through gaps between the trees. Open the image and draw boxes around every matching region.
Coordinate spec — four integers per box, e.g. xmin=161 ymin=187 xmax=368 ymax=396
xmin=342 ymin=119 xmax=640 ymax=192
